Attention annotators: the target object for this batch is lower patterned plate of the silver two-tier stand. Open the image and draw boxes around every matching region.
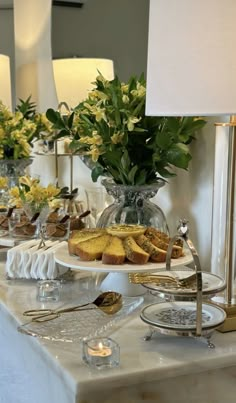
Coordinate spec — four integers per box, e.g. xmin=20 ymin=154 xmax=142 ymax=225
xmin=140 ymin=301 xmax=226 ymax=331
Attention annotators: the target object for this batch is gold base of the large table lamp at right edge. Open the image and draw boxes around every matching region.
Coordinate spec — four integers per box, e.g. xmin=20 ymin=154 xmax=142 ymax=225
xmin=211 ymin=297 xmax=236 ymax=333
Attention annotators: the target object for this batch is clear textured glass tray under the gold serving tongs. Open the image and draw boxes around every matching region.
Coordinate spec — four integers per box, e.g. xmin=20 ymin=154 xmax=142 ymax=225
xmin=18 ymin=291 xmax=144 ymax=343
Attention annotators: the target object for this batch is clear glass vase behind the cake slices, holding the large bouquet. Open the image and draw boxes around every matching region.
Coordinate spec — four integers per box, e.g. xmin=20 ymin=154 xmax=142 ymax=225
xmin=97 ymin=179 xmax=169 ymax=234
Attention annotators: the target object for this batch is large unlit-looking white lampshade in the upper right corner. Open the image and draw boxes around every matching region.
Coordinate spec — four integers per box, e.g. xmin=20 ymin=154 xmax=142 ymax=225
xmin=146 ymin=0 xmax=236 ymax=116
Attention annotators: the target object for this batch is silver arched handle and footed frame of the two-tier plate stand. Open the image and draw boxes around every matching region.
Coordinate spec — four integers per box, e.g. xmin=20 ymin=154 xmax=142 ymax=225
xmin=144 ymin=220 xmax=215 ymax=348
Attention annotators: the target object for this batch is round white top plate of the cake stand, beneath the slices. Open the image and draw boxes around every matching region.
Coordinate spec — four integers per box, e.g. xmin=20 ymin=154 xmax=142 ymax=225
xmin=54 ymin=245 xmax=193 ymax=273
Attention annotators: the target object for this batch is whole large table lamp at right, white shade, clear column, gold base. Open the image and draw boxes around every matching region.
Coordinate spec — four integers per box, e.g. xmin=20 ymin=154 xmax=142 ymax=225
xmin=146 ymin=0 xmax=236 ymax=331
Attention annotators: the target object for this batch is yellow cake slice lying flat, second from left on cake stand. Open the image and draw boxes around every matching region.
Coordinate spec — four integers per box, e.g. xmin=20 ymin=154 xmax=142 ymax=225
xmin=75 ymin=234 xmax=111 ymax=261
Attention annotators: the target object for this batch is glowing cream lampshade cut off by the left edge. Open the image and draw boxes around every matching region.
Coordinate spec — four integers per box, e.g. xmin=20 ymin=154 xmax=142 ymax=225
xmin=0 ymin=55 xmax=12 ymax=110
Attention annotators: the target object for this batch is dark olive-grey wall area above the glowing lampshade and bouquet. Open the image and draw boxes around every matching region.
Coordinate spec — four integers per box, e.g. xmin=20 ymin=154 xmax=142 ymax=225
xmin=52 ymin=0 xmax=149 ymax=81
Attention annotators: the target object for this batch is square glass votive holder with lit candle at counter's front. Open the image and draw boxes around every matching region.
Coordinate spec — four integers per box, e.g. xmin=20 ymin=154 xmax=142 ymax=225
xmin=82 ymin=337 xmax=120 ymax=369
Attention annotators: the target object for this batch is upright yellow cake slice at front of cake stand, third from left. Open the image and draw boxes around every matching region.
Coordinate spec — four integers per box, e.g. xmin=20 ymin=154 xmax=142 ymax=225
xmin=102 ymin=236 xmax=126 ymax=265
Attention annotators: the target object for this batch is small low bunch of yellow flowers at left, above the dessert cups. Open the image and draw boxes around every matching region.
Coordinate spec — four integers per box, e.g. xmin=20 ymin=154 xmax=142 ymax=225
xmin=9 ymin=176 xmax=60 ymax=214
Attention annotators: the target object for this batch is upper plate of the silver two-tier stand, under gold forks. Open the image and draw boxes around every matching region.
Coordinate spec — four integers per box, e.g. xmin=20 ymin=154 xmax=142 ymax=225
xmin=143 ymin=268 xmax=226 ymax=297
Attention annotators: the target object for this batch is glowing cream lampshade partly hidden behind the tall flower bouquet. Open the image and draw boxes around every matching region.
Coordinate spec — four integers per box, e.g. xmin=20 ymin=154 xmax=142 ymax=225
xmin=53 ymin=58 xmax=114 ymax=108
